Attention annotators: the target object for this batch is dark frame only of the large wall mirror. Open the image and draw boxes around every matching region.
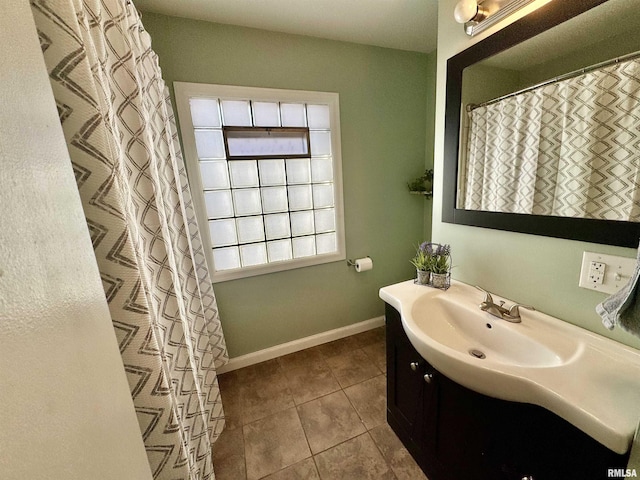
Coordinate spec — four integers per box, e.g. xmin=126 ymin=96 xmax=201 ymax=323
xmin=442 ymin=0 xmax=640 ymax=248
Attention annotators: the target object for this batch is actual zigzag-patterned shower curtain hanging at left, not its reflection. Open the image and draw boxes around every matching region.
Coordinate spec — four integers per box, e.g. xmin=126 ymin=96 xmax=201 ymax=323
xmin=31 ymin=0 xmax=228 ymax=480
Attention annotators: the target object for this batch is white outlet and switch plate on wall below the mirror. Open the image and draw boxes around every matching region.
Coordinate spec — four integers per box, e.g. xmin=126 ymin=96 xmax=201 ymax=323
xmin=579 ymin=252 xmax=636 ymax=293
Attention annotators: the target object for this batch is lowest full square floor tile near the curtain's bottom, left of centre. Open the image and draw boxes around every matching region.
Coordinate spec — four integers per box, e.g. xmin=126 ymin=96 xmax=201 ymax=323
xmin=243 ymin=408 xmax=311 ymax=480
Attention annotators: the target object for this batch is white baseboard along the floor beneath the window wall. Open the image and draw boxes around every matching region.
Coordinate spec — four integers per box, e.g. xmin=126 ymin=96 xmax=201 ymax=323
xmin=218 ymin=316 xmax=384 ymax=373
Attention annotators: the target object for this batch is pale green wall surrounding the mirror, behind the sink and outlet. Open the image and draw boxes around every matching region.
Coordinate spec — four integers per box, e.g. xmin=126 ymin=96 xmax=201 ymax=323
xmin=432 ymin=0 xmax=640 ymax=348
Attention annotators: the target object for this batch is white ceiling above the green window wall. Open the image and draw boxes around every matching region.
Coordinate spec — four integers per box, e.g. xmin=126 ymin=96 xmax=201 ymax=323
xmin=134 ymin=0 xmax=438 ymax=53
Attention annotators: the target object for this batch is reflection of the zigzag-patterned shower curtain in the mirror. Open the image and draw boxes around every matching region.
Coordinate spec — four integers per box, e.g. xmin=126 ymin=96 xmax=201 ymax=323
xmin=462 ymin=58 xmax=640 ymax=222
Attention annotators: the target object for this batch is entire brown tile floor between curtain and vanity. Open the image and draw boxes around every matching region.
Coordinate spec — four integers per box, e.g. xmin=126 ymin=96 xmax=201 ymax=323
xmin=213 ymin=327 xmax=426 ymax=480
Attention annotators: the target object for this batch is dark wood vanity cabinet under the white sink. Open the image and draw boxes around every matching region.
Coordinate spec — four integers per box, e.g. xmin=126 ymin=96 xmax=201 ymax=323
xmin=386 ymin=305 xmax=628 ymax=480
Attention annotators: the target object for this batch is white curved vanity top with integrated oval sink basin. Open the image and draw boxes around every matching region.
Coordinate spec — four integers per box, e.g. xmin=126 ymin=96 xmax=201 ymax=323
xmin=380 ymin=281 xmax=640 ymax=453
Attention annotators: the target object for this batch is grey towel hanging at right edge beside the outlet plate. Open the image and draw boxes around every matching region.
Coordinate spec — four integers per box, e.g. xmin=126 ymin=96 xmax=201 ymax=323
xmin=596 ymin=244 xmax=640 ymax=337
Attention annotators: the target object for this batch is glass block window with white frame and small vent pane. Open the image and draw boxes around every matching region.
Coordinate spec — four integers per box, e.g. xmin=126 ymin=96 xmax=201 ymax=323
xmin=174 ymin=82 xmax=345 ymax=281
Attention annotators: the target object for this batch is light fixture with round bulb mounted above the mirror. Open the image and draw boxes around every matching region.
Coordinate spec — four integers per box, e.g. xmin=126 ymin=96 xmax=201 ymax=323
xmin=453 ymin=0 xmax=536 ymax=36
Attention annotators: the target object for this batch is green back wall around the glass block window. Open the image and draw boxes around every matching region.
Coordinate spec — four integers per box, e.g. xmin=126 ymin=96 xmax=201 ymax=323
xmin=143 ymin=12 xmax=435 ymax=357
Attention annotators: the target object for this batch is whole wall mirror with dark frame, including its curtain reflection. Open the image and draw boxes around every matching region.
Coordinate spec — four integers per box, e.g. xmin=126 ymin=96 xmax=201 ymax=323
xmin=442 ymin=0 xmax=640 ymax=247
